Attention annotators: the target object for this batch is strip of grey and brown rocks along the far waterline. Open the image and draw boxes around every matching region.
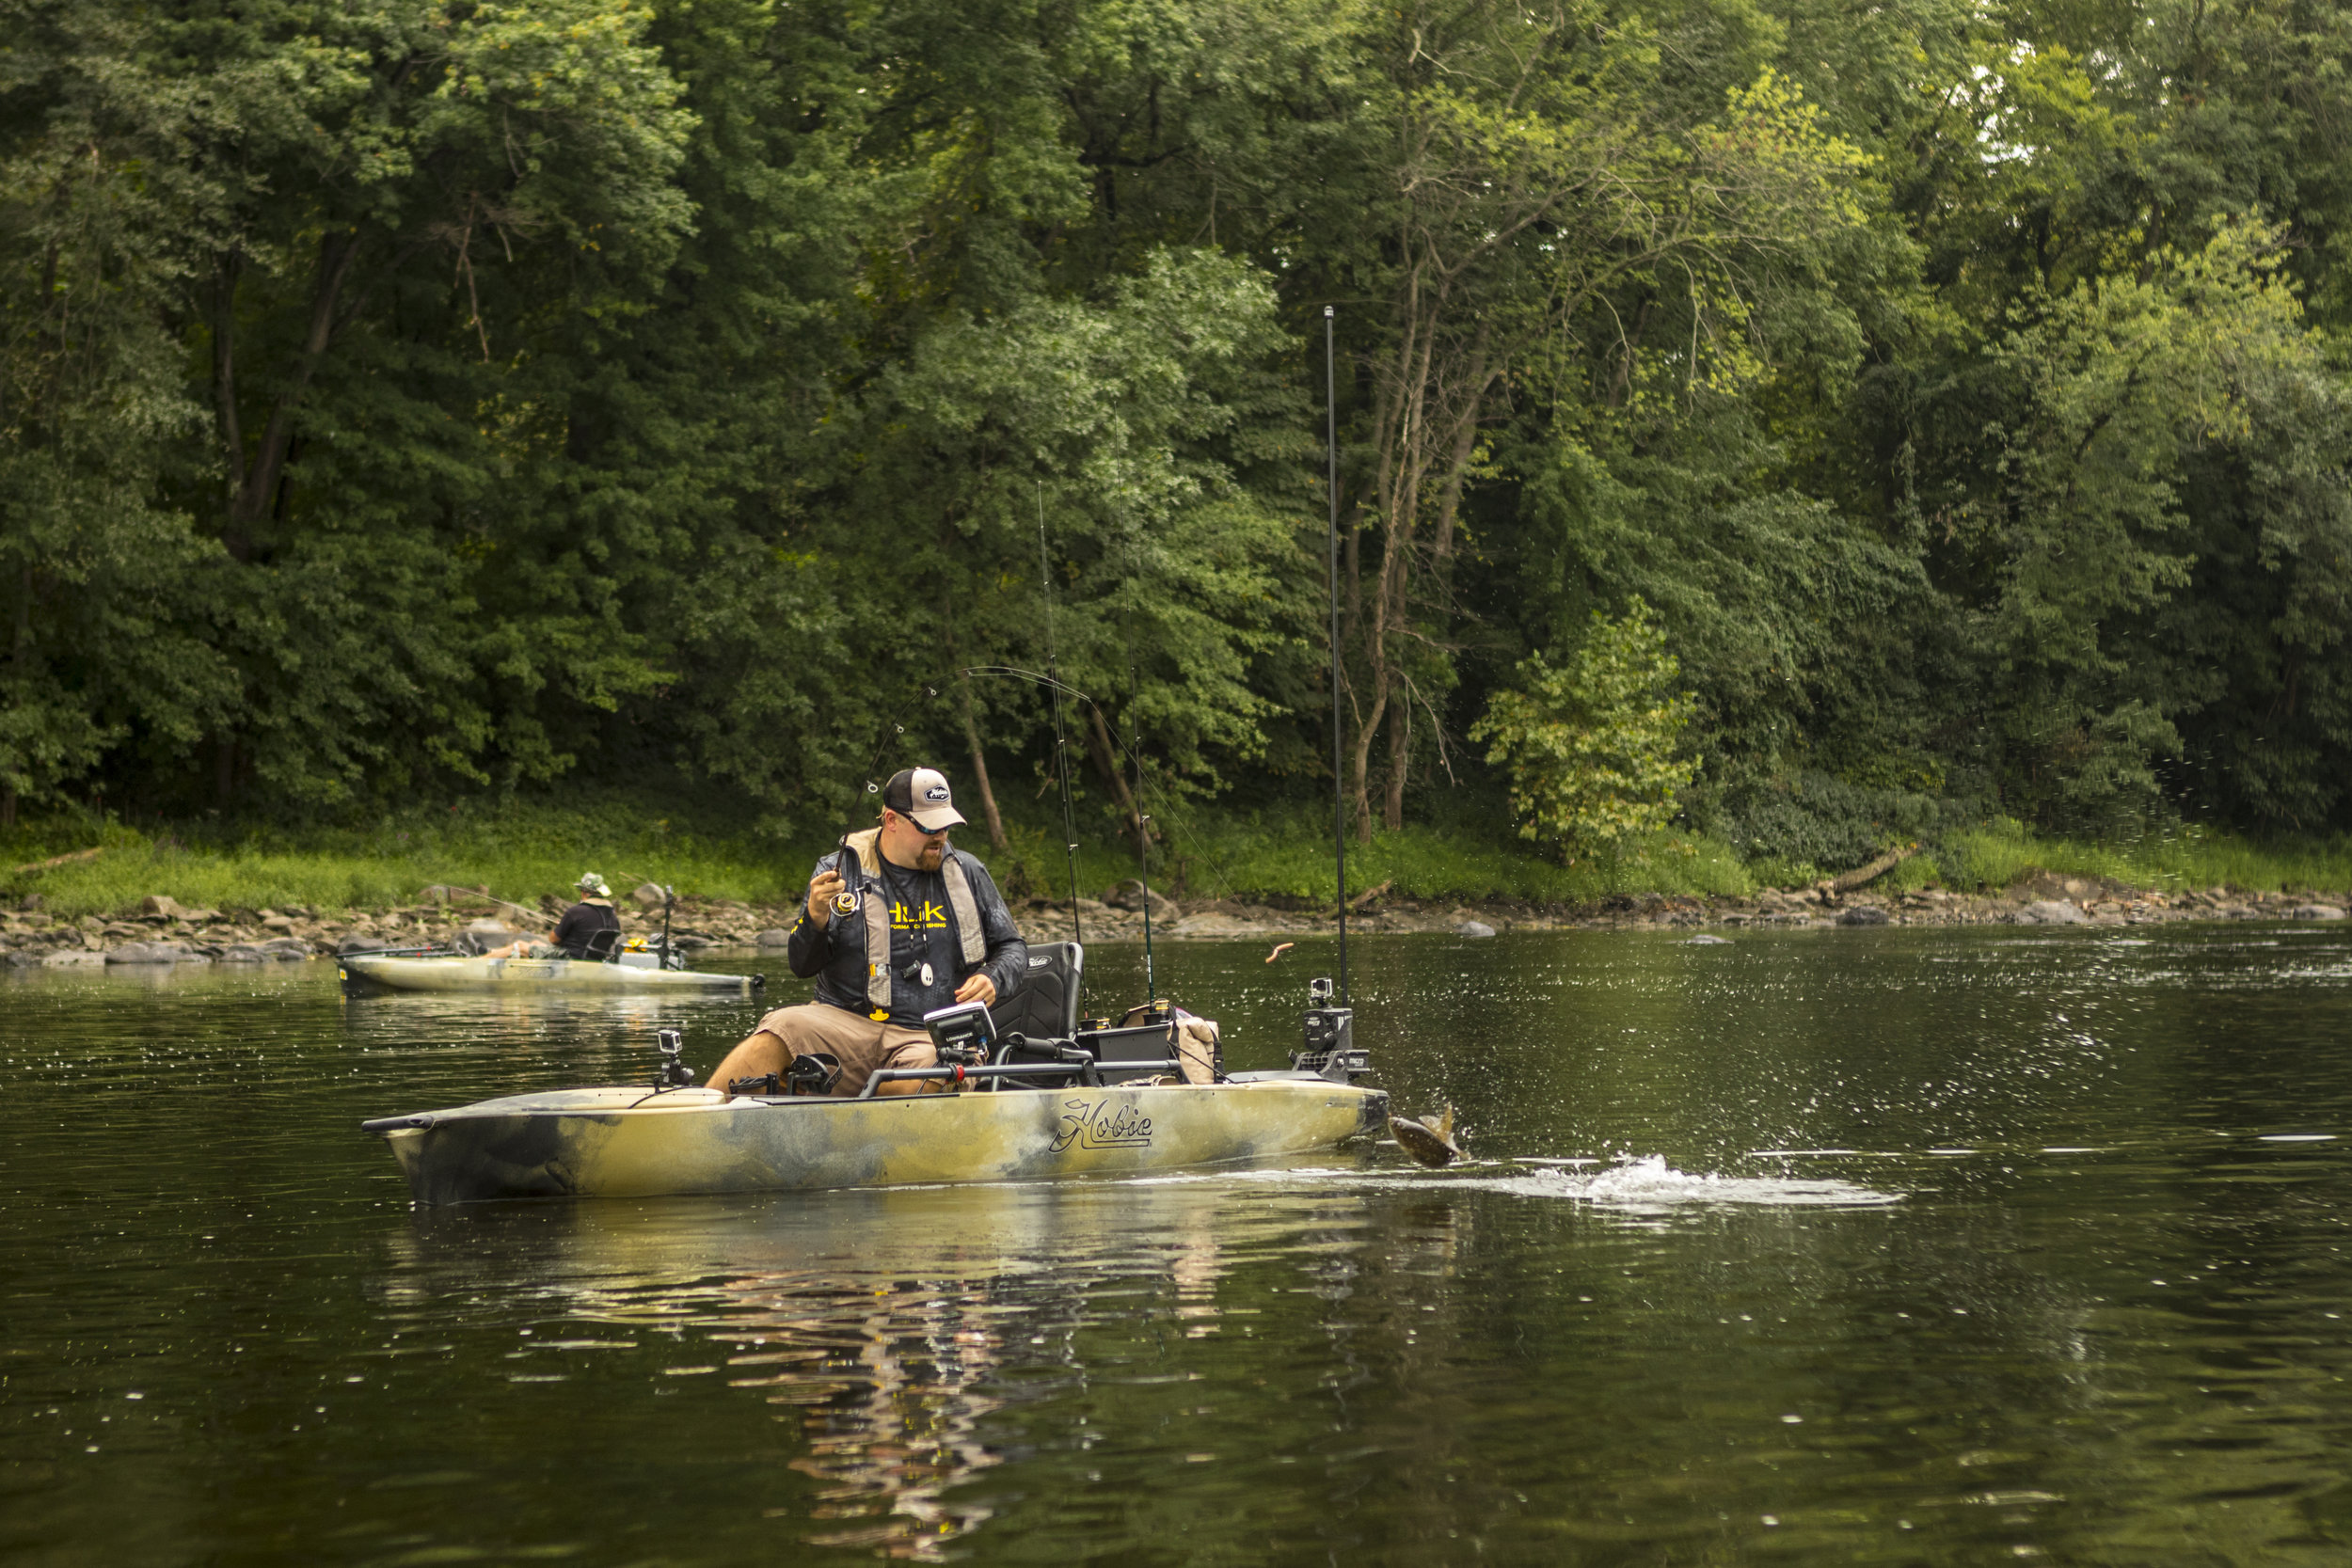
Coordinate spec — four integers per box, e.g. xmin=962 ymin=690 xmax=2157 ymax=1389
xmin=0 ymin=875 xmax=2352 ymax=966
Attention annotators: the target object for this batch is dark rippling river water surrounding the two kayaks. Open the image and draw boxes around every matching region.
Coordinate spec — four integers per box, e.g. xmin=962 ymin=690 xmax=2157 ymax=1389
xmin=0 ymin=927 xmax=2352 ymax=1568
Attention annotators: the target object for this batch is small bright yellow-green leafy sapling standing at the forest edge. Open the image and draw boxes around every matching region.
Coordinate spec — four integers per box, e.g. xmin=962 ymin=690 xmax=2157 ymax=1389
xmin=1470 ymin=597 xmax=1701 ymax=861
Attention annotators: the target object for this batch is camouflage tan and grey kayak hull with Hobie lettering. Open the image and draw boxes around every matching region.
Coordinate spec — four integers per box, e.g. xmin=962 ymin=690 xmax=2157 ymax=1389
xmin=370 ymin=1077 xmax=1388 ymax=1204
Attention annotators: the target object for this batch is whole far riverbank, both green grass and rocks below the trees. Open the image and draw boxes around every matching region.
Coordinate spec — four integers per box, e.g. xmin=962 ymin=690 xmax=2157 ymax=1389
xmin=0 ymin=797 xmax=2352 ymax=964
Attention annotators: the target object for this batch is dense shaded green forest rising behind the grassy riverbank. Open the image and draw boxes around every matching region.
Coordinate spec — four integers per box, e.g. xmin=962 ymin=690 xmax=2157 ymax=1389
xmin=0 ymin=0 xmax=2352 ymax=867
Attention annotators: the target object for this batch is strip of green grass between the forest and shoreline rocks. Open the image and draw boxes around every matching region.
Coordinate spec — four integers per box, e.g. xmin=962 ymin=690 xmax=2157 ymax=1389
xmin=0 ymin=800 xmax=2352 ymax=917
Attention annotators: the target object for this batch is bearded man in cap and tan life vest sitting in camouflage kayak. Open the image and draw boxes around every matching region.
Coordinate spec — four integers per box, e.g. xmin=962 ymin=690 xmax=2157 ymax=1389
xmin=710 ymin=768 xmax=1028 ymax=1096
